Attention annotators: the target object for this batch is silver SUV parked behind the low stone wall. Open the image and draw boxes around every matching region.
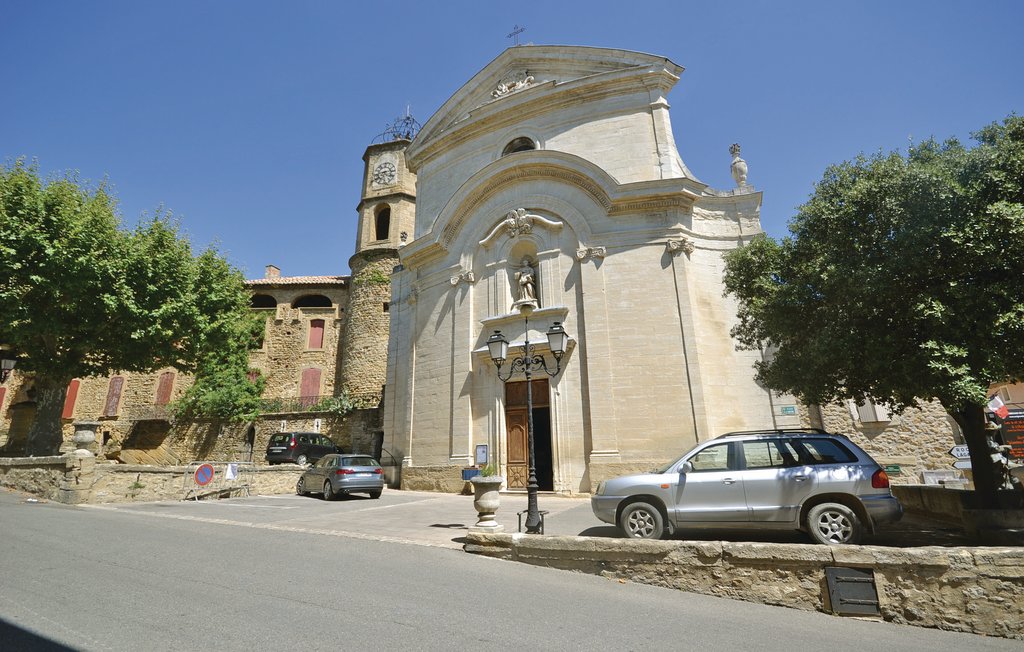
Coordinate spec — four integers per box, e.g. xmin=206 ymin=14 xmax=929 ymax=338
xmin=591 ymin=429 xmax=903 ymax=544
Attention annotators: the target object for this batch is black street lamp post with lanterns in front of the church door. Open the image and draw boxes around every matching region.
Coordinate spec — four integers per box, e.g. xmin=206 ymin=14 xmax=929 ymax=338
xmin=487 ymin=311 xmax=569 ymax=534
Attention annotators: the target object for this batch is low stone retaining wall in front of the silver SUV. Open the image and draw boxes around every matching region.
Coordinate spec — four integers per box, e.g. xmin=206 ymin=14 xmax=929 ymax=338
xmin=465 ymin=532 xmax=1024 ymax=639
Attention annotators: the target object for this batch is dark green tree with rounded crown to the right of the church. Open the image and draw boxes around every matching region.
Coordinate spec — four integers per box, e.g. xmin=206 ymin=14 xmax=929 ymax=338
xmin=725 ymin=116 xmax=1024 ymax=507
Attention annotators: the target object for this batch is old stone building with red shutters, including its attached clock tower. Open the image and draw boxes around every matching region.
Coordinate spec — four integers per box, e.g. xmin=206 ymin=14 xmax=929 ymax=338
xmin=0 ymin=129 xmax=416 ymax=465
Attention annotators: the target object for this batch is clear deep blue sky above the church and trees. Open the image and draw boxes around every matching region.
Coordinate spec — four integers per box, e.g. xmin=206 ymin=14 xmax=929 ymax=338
xmin=0 ymin=0 xmax=1024 ymax=277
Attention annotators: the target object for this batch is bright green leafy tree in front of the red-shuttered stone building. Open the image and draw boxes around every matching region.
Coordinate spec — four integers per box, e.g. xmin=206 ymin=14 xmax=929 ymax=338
xmin=0 ymin=160 xmax=258 ymax=455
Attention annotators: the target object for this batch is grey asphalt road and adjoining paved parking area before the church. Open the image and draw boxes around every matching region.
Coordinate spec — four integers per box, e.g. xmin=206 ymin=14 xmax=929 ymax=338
xmin=0 ymin=491 xmax=1020 ymax=652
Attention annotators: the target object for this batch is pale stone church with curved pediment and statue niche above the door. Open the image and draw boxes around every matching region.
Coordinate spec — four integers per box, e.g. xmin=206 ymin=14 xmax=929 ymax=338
xmin=383 ymin=45 xmax=801 ymax=493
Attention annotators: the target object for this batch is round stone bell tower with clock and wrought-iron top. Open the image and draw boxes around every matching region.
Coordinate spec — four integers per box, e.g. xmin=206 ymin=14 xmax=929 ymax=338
xmin=339 ymin=115 xmax=420 ymax=398
